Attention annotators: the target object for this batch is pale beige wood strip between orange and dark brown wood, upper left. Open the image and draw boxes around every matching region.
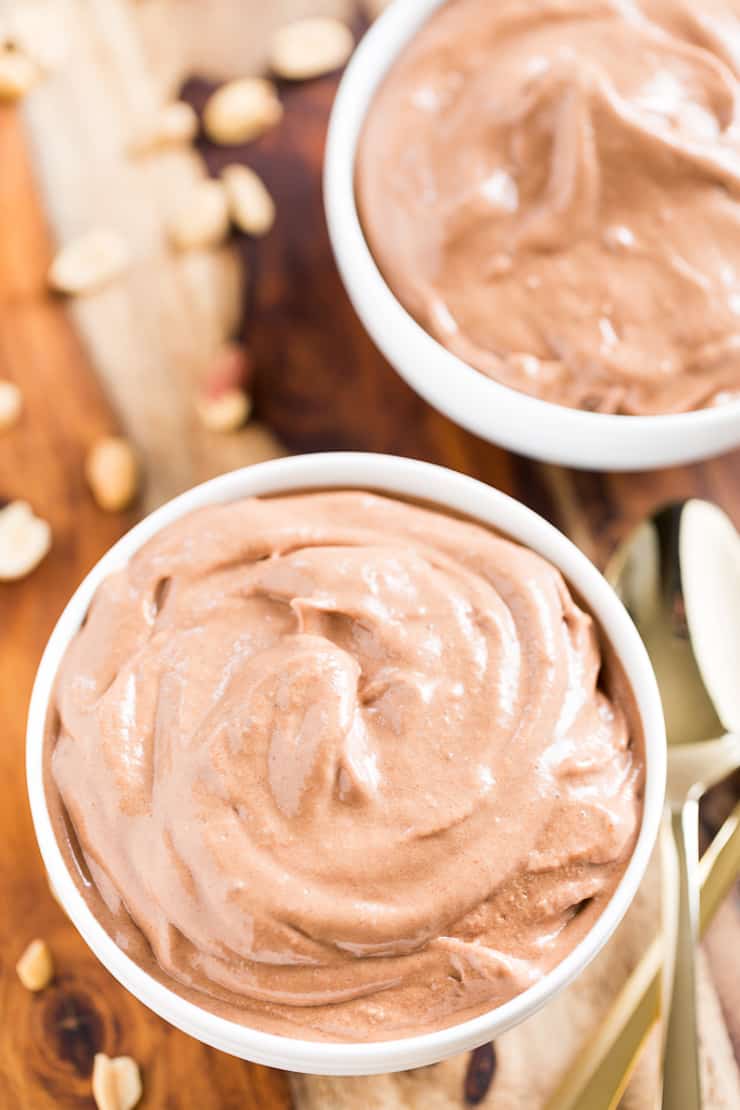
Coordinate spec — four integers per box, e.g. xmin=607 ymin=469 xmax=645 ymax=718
xmin=19 ymin=0 xmax=280 ymax=509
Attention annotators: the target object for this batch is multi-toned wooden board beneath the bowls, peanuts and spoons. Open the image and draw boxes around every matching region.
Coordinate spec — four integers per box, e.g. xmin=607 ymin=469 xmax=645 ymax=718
xmin=0 ymin=0 xmax=740 ymax=1110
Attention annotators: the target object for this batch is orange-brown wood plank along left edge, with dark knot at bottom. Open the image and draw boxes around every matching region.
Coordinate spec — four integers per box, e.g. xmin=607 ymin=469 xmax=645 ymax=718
xmin=0 ymin=109 xmax=290 ymax=1110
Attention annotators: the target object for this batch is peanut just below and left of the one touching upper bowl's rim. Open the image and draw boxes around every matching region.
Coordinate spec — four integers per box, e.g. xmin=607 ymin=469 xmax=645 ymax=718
xmin=203 ymin=77 xmax=283 ymax=145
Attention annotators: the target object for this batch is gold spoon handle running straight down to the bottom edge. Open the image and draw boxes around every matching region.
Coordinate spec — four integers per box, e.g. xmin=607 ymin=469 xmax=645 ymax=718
xmin=662 ymin=800 xmax=701 ymax=1110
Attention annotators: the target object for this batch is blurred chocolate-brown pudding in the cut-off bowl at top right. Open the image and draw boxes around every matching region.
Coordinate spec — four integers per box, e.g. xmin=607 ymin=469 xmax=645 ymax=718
xmin=356 ymin=0 xmax=740 ymax=414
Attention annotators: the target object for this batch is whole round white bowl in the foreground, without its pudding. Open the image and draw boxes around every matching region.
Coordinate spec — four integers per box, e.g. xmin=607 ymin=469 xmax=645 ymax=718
xmin=27 ymin=453 xmax=666 ymax=1074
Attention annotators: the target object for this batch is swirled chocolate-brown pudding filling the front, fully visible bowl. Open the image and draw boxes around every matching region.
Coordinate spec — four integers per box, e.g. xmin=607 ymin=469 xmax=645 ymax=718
xmin=49 ymin=492 xmax=642 ymax=1040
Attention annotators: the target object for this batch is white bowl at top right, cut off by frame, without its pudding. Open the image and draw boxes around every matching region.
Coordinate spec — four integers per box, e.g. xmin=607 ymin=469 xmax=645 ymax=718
xmin=324 ymin=0 xmax=740 ymax=471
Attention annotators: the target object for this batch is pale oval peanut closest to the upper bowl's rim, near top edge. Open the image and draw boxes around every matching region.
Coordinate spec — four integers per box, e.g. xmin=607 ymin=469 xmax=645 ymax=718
xmin=270 ymin=18 xmax=355 ymax=81
